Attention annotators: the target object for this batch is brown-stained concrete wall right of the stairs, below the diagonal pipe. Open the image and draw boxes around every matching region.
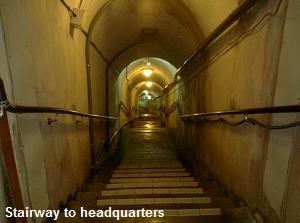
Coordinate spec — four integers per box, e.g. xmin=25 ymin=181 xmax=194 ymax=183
xmin=173 ymin=1 xmax=299 ymax=222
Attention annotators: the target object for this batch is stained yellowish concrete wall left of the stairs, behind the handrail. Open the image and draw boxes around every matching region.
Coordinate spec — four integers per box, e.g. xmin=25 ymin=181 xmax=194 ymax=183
xmin=0 ymin=0 xmax=105 ymax=218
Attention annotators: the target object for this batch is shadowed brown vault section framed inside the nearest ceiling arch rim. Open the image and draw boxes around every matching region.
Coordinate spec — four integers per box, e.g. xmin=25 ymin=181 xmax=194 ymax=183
xmin=93 ymin=0 xmax=202 ymax=69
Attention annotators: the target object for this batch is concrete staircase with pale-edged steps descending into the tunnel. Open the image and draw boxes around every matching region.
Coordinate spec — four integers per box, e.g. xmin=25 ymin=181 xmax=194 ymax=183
xmin=58 ymin=121 xmax=251 ymax=223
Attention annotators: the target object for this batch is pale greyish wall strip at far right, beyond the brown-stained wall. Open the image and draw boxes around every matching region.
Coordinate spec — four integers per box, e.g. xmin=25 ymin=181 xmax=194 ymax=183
xmin=264 ymin=0 xmax=300 ymax=222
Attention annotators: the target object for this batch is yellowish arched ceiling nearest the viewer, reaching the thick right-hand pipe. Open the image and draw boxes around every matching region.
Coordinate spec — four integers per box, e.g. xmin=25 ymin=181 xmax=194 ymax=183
xmin=79 ymin=0 xmax=240 ymax=70
